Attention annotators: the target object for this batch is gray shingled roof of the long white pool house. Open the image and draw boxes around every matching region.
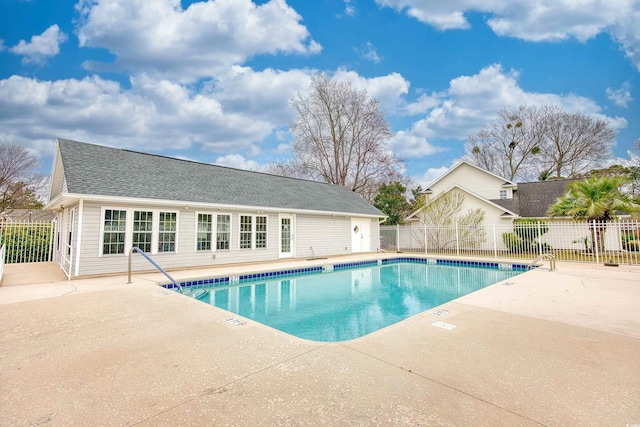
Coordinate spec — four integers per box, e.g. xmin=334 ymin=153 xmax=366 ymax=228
xmin=58 ymin=139 xmax=384 ymax=217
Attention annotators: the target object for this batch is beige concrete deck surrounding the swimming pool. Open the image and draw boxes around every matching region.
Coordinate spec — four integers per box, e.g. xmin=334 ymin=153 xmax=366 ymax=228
xmin=0 ymin=255 xmax=640 ymax=426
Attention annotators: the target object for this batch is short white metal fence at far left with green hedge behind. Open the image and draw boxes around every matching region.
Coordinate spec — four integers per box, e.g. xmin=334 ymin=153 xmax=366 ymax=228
xmin=0 ymin=222 xmax=54 ymax=264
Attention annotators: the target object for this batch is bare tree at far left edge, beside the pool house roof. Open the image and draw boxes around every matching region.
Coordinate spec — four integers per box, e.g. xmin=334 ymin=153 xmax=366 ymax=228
xmin=0 ymin=143 xmax=44 ymax=213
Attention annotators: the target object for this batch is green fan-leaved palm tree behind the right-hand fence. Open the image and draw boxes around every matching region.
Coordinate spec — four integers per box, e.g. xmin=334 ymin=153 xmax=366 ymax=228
xmin=547 ymin=176 xmax=640 ymax=253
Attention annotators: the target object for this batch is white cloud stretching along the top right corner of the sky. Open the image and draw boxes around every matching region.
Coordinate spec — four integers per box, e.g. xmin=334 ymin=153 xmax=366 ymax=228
xmin=376 ymin=0 xmax=640 ymax=70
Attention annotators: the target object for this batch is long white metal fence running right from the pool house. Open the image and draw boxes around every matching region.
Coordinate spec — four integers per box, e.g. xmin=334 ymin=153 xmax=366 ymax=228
xmin=380 ymin=221 xmax=640 ymax=264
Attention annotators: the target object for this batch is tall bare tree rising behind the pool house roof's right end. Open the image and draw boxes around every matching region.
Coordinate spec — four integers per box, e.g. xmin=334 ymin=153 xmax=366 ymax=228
xmin=267 ymin=74 xmax=404 ymax=201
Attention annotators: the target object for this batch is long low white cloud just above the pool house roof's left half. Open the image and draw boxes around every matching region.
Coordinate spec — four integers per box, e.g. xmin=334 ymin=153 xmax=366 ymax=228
xmin=0 ymin=76 xmax=274 ymax=152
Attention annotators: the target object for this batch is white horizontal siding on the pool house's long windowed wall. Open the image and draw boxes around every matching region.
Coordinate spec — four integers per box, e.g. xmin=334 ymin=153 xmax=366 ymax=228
xmin=73 ymin=201 xmax=378 ymax=277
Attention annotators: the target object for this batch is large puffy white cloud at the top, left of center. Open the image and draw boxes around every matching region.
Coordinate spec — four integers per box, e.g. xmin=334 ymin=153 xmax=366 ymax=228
xmin=77 ymin=0 xmax=321 ymax=82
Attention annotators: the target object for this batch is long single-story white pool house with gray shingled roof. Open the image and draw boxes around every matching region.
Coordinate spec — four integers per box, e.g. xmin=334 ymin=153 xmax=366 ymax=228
xmin=45 ymin=139 xmax=384 ymax=278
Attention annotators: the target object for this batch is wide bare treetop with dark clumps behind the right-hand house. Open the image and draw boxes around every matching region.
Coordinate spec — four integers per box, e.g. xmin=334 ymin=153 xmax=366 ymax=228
xmin=465 ymin=106 xmax=616 ymax=181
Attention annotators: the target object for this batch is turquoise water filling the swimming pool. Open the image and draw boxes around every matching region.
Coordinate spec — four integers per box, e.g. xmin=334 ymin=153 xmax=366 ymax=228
xmin=186 ymin=260 xmax=522 ymax=341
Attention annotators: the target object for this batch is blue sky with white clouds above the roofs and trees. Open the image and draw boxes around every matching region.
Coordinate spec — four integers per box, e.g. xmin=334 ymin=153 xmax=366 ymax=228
xmin=0 ymin=0 xmax=640 ymax=185
